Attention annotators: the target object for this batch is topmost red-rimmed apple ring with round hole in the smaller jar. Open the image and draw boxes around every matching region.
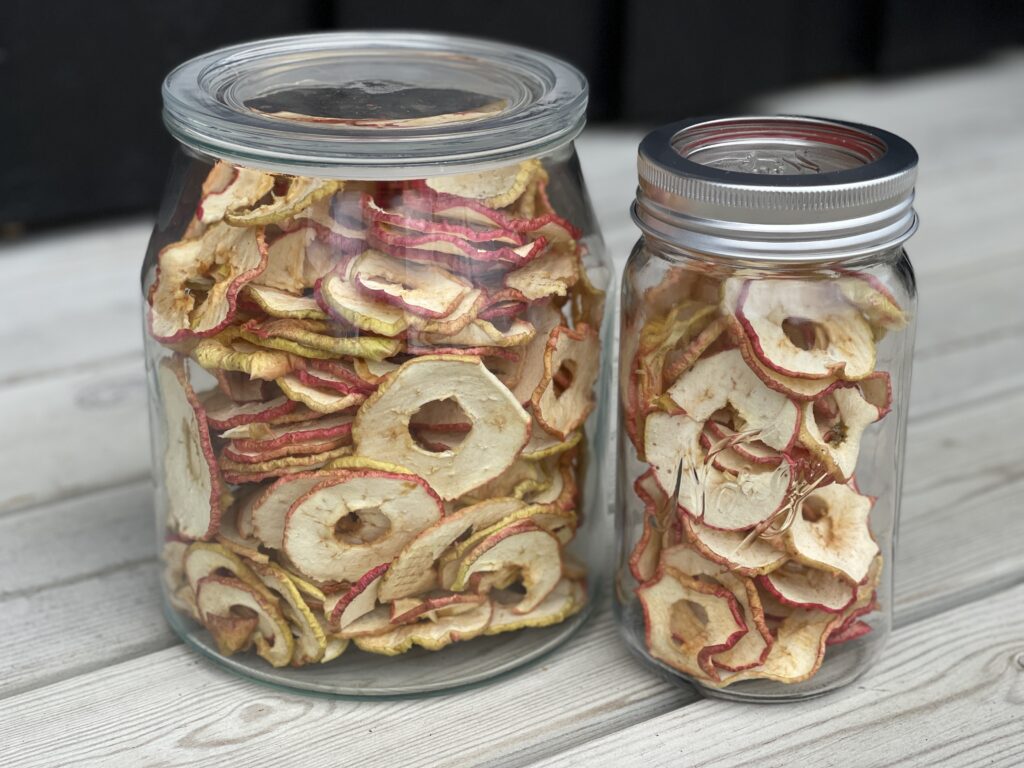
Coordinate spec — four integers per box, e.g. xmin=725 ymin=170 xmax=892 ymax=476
xmin=736 ymin=280 xmax=874 ymax=380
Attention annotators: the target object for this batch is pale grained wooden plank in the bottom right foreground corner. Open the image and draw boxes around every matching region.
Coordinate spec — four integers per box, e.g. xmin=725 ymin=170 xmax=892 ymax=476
xmin=520 ymin=587 xmax=1024 ymax=768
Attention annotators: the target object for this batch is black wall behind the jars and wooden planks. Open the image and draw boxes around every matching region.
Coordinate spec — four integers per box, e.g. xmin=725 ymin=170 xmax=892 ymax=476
xmin=0 ymin=0 xmax=1024 ymax=234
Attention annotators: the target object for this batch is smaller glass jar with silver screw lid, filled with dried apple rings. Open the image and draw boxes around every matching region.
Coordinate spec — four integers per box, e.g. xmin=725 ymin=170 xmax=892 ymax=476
xmin=615 ymin=117 xmax=918 ymax=700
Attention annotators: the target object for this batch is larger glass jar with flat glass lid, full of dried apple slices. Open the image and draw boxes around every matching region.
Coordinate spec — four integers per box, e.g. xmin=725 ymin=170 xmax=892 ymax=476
xmin=142 ymin=34 xmax=610 ymax=696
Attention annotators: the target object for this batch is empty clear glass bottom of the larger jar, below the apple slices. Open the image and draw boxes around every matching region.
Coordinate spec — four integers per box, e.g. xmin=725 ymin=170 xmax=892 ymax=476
xmin=163 ymin=593 xmax=594 ymax=699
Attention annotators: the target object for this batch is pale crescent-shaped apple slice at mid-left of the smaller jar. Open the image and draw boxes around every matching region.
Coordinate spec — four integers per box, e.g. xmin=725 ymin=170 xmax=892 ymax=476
xmin=644 ymin=412 xmax=793 ymax=530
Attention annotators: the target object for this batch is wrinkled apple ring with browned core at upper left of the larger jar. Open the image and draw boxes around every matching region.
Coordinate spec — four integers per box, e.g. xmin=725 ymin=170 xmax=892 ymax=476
xmin=148 ymin=224 xmax=267 ymax=344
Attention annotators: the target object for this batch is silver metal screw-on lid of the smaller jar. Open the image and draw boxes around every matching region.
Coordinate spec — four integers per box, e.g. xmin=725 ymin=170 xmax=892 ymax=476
xmin=633 ymin=116 xmax=918 ymax=262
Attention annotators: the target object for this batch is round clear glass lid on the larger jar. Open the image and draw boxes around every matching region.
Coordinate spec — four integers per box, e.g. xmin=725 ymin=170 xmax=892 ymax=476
xmin=163 ymin=32 xmax=588 ymax=179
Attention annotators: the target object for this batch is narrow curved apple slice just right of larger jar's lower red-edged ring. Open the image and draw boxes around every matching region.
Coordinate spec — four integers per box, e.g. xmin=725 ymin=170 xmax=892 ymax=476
xmin=380 ymin=498 xmax=525 ymax=601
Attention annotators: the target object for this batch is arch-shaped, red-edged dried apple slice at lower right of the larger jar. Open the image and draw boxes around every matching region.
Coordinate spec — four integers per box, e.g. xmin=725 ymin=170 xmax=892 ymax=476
xmin=452 ymin=518 xmax=562 ymax=614
